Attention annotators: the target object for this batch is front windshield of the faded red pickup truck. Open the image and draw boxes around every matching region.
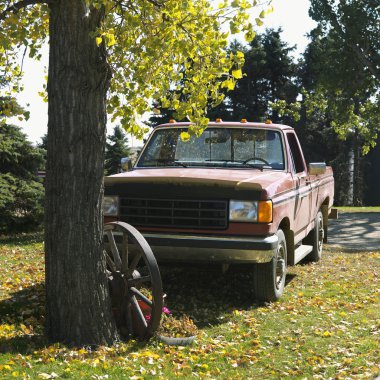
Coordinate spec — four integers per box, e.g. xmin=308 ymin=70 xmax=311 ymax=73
xmin=136 ymin=128 xmax=284 ymax=170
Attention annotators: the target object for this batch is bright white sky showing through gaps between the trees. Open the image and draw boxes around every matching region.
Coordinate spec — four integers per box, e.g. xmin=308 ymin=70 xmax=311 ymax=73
xmin=12 ymin=0 xmax=316 ymax=146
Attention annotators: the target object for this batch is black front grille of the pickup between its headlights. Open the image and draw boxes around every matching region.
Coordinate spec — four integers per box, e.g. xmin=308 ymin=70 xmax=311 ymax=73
xmin=120 ymin=198 xmax=228 ymax=229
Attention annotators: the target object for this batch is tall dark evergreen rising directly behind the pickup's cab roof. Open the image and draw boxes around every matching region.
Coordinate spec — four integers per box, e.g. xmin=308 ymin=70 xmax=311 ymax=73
xmin=220 ymin=29 xmax=298 ymax=121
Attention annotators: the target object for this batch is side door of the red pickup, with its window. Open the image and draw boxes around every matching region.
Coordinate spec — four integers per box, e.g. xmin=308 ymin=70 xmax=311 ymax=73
xmin=286 ymin=132 xmax=311 ymax=242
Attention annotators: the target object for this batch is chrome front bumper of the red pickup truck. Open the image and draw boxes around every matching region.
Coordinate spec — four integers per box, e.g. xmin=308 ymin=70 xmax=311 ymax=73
xmin=137 ymin=233 xmax=278 ymax=263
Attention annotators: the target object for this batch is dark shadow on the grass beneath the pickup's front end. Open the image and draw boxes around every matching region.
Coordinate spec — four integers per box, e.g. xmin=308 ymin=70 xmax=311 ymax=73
xmin=161 ymin=265 xmax=295 ymax=328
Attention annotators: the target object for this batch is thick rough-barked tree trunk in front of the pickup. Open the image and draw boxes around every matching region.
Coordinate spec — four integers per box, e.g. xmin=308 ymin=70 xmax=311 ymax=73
xmin=45 ymin=0 xmax=117 ymax=346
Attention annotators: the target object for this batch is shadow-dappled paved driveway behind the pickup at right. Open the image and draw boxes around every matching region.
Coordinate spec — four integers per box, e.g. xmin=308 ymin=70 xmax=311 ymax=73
xmin=328 ymin=212 xmax=380 ymax=251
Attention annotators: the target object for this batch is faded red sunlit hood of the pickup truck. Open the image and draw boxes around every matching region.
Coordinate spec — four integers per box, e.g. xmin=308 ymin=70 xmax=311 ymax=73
xmin=104 ymin=168 xmax=287 ymax=191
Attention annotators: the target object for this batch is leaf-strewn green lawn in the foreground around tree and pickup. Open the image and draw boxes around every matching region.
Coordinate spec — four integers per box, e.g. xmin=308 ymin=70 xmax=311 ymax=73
xmin=0 ymin=235 xmax=380 ymax=379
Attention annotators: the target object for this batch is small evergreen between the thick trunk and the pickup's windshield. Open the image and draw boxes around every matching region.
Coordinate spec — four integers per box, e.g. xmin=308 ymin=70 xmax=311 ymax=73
xmin=104 ymin=126 xmax=130 ymax=175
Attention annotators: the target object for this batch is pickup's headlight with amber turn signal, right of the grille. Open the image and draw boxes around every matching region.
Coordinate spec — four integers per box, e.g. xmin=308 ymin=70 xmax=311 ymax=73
xmin=230 ymin=200 xmax=273 ymax=223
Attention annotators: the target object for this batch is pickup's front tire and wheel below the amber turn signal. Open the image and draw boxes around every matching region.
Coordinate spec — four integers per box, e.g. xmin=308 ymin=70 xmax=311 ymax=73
xmin=253 ymin=230 xmax=287 ymax=302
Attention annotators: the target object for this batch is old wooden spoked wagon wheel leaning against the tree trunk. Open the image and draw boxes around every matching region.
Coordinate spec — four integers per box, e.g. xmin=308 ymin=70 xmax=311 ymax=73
xmin=104 ymin=222 xmax=163 ymax=339
